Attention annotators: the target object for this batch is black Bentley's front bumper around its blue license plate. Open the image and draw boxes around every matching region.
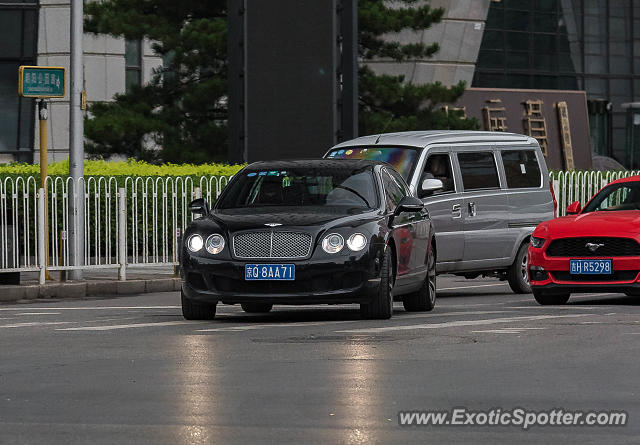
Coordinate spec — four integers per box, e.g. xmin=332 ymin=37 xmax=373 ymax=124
xmin=182 ymin=253 xmax=380 ymax=304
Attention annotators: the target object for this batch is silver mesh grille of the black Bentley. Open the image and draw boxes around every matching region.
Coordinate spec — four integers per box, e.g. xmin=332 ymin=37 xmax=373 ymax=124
xmin=233 ymin=231 xmax=312 ymax=258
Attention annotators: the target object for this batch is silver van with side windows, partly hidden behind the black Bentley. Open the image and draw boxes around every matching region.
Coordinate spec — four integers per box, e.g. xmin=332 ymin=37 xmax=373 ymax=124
xmin=325 ymin=130 xmax=555 ymax=293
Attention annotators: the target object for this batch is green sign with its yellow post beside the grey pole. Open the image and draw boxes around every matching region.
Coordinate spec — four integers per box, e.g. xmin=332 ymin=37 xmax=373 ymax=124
xmin=18 ymin=65 xmax=65 ymax=279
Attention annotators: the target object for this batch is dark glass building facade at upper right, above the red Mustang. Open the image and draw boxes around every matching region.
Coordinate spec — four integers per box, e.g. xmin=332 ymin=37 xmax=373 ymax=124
xmin=472 ymin=0 xmax=640 ymax=164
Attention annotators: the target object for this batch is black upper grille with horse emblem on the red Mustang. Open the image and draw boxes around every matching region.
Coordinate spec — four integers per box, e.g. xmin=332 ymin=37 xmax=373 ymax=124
xmin=547 ymin=237 xmax=640 ymax=257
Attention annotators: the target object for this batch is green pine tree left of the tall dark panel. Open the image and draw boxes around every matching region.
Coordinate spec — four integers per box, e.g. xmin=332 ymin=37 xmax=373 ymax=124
xmin=85 ymin=0 xmax=227 ymax=163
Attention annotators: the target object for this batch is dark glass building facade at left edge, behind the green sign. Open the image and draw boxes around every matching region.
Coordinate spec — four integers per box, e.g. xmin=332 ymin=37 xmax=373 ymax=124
xmin=0 ymin=0 xmax=38 ymax=162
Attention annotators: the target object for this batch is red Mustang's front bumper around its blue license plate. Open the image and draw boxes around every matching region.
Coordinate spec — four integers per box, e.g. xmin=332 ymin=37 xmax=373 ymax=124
xmin=529 ymin=247 xmax=640 ymax=294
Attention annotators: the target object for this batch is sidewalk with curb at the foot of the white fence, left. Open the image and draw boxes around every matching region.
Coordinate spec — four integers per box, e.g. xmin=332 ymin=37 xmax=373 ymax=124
xmin=0 ymin=266 xmax=181 ymax=303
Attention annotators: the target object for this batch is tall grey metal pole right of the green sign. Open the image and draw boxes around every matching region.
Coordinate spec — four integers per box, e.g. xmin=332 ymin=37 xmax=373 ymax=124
xmin=69 ymin=0 xmax=84 ymax=280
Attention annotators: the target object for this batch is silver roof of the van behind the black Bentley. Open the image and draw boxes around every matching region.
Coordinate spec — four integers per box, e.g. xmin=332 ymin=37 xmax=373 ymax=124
xmin=333 ymin=130 xmax=535 ymax=148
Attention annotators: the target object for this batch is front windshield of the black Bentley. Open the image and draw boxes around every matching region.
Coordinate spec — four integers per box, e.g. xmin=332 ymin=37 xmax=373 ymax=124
xmin=216 ymin=167 xmax=378 ymax=209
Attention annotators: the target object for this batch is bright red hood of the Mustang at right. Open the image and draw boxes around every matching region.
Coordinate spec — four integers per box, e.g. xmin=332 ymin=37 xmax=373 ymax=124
xmin=536 ymin=210 xmax=640 ymax=238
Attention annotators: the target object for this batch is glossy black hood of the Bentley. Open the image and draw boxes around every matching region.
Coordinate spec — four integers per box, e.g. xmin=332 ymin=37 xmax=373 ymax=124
xmin=209 ymin=207 xmax=377 ymax=232
